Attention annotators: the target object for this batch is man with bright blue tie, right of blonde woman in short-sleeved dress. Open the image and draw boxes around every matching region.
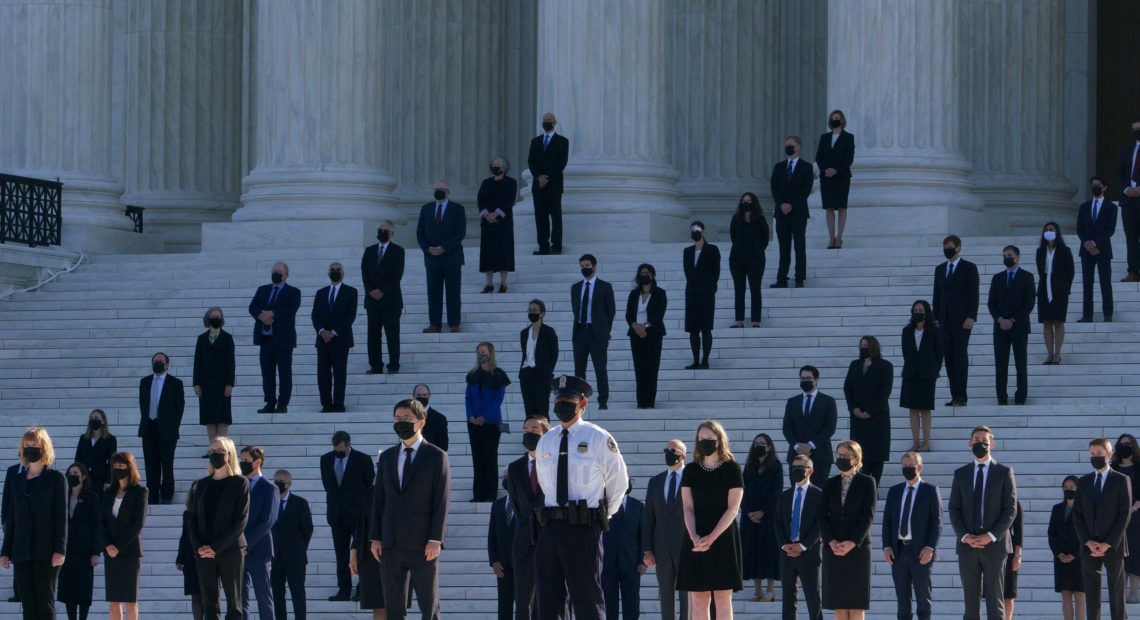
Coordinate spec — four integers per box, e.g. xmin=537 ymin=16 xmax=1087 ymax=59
xmin=775 ymin=455 xmax=823 ymax=620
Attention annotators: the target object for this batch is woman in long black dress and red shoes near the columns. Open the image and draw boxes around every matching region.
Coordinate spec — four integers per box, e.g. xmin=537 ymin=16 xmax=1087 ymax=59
xmin=477 ymin=157 xmax=519 ymax=293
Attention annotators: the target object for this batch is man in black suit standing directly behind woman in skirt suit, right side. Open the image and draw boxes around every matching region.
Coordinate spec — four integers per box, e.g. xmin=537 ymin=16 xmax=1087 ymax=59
xmin=931 ymin=235 xmax=979 ymax=407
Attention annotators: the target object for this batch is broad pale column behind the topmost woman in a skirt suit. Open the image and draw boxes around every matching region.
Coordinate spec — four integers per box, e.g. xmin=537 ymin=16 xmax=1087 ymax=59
xmin=825 ymin=0 xmax=983 ymax=235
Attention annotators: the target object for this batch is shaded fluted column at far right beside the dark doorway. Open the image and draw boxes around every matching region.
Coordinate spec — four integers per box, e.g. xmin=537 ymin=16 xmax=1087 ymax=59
xmin=959 ymin=0 xmax=1076 ymax=234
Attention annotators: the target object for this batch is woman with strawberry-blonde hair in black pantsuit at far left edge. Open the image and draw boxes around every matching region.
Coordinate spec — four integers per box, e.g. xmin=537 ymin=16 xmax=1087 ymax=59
xmin=0 ymin=426 xmax=67 ymax=620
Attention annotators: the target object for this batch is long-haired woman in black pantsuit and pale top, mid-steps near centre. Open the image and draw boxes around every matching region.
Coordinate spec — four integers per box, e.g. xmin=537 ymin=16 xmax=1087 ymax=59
xmin=626 ymin=262 xmax=669 ymax=409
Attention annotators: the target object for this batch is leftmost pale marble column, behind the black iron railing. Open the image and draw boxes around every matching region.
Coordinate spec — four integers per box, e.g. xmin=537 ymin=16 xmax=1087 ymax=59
xmin=0 ymin=0 xmax=133 ymax=251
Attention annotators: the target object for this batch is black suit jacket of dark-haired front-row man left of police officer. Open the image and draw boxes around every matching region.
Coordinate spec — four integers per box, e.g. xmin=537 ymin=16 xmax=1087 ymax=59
xmin=368 ymin=441 xmax=451 ymax=549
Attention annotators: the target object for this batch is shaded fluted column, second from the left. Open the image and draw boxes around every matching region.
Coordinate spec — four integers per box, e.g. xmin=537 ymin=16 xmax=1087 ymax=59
xmin=122 ymin=0 xmax=243 ymax=251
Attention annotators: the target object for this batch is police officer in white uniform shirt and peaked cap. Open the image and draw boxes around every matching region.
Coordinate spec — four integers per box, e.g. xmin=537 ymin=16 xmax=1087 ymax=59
xmin=535 ymin=375 xmax=629 ymax=620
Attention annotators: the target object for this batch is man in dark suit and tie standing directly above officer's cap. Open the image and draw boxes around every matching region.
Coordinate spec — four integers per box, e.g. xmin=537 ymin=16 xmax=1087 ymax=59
xmin=570 ymin=254 xmax=617 ymax=409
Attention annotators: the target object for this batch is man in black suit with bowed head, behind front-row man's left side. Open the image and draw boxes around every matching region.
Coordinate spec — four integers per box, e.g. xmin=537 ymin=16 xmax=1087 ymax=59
xmin=320 ymin=431 xmax=376 ymax=601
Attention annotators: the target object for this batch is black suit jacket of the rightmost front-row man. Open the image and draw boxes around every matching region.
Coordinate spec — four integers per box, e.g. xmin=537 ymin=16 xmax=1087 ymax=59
xmin=1073 ymin=470 xmax=1132 ymax=555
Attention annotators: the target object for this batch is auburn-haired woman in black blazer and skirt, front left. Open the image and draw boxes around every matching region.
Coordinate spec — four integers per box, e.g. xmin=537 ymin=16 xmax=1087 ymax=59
xmin=101 ymin=452 xmax=147 ymax=620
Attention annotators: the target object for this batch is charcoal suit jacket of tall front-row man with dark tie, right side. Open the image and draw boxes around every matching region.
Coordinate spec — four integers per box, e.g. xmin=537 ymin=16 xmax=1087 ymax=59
xmin=950 ymin=458 xmax=1017 ymax=553
